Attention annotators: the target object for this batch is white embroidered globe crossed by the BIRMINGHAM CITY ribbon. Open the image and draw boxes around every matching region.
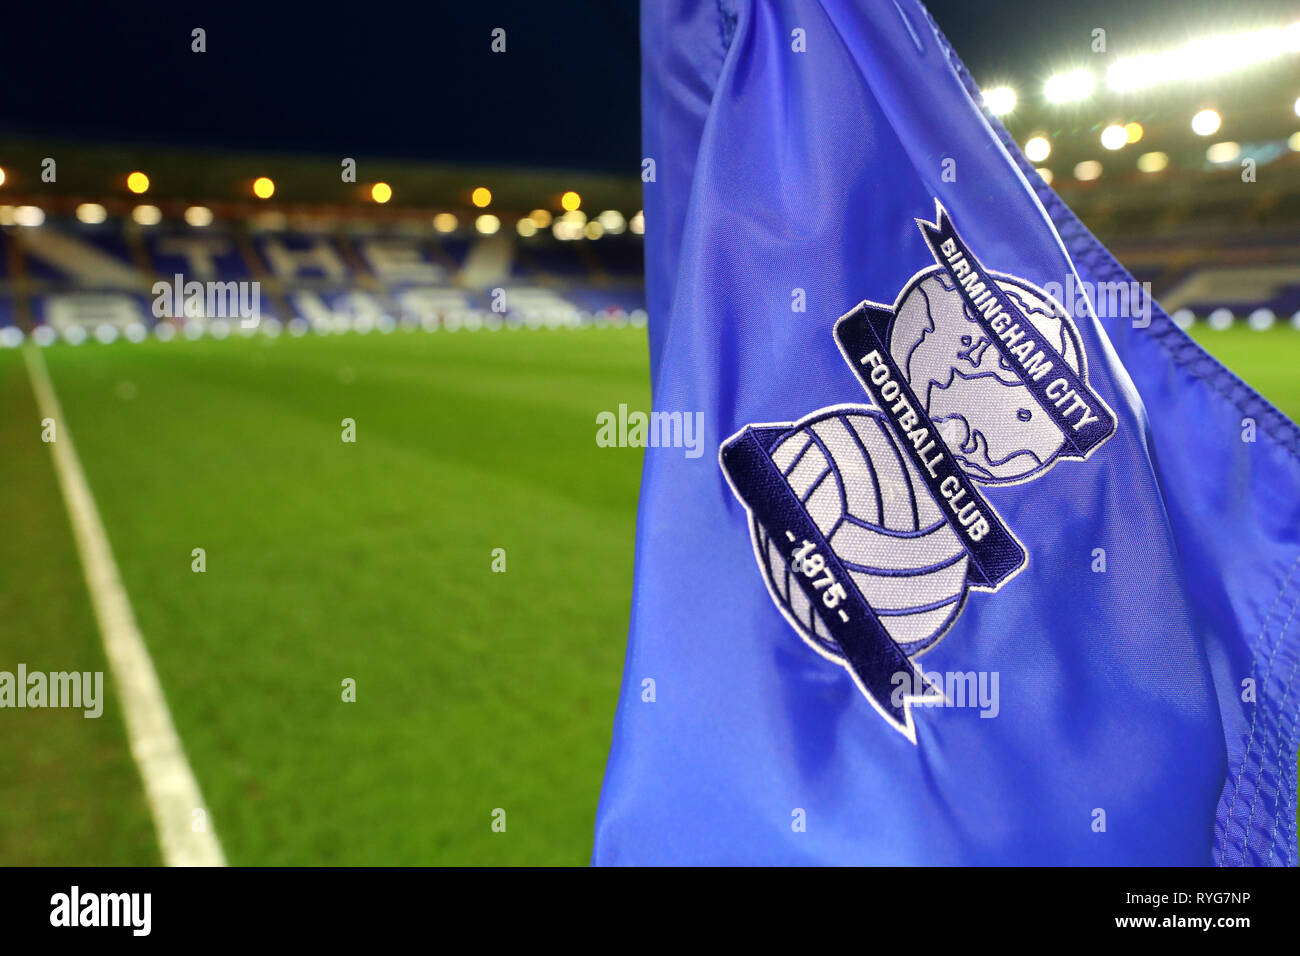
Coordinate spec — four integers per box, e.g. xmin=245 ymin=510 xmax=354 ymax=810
xmin=889 ymin=265 xmax=1084 ymax=484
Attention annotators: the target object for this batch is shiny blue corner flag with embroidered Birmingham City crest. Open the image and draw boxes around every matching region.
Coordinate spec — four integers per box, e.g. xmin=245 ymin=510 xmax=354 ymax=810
xmin=593 ymin=0 xmax=1300 ymax=865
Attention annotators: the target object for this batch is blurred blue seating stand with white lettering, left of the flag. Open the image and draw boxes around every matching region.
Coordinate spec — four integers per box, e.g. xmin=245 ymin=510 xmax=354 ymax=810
xmin=0 ymin=217 xmax=645 ymax=346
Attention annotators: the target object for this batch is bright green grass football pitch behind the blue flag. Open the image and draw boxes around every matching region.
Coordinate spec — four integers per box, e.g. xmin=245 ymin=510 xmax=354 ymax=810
xmin=0 ymin=328 xmax=1300 ymax=865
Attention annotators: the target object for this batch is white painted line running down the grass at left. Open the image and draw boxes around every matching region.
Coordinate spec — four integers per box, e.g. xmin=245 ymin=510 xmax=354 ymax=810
xmin=23 ymin=342 xmax=226 ymax=866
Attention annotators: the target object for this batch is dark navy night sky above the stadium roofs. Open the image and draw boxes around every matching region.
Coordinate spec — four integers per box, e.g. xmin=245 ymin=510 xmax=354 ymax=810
xmin=0 ymin=0 xmax=1300 ymax=172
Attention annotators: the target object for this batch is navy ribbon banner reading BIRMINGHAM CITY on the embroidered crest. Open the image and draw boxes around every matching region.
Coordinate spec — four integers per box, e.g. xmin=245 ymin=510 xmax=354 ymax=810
xmin=915 ymin=207 xmax=1115 ymax=459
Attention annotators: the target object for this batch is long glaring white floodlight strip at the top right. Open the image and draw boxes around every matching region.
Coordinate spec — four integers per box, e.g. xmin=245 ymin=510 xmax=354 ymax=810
xmin=1106 ymin=23 xmax=1300 ymax=94
